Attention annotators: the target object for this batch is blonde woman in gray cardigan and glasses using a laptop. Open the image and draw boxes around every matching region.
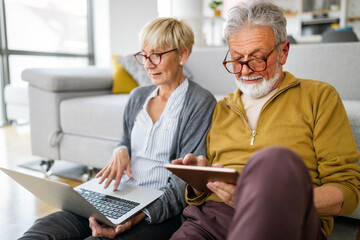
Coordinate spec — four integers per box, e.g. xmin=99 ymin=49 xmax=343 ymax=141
xmin=23 ymin=18 xmax=216 ymax=239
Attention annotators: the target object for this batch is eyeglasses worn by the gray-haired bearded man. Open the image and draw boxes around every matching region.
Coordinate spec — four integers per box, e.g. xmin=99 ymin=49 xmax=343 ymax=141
xmin=223 ymin=43 xmax=281 ymax=74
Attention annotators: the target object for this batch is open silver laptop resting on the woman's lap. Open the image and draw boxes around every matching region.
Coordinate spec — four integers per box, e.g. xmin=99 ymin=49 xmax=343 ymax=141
xmin=0 ymin=167 xmax=163 ymax=227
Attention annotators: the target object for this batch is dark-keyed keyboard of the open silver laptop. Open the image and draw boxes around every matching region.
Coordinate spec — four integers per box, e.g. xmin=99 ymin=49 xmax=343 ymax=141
xmin=79 ymin=188 xmax=139 ymax=219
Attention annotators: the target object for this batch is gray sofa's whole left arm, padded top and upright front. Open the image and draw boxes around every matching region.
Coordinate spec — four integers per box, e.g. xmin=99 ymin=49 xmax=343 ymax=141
xmin=22 ymin=67 xmax=113 ymax=159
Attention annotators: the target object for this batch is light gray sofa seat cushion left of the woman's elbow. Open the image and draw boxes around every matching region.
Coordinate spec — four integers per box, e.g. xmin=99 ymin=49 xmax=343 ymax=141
xmin=60 ymin=94 xmax=129 ymax=141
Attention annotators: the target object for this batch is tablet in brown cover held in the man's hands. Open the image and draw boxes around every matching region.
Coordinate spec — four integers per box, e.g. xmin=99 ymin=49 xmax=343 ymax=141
xmin=164 ymin=164 xmax=239 ymax=192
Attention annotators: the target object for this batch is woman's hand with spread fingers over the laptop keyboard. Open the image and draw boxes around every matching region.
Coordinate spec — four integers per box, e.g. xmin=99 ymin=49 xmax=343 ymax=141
xmin=95 ymin=147 xmax=132 ymax=191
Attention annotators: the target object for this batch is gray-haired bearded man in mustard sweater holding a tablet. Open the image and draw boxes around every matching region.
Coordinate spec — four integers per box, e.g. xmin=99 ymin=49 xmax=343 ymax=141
xmin=172 ymin=1 xmax=360 ymax=240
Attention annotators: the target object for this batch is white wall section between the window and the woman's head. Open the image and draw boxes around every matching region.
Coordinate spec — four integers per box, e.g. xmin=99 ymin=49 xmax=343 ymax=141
xmin=94 ymin=0 xmax=158 ymax=67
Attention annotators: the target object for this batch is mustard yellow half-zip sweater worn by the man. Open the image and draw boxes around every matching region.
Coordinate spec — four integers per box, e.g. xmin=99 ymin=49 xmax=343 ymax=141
xmin=186 ymin=72 xmax=360 ymax=235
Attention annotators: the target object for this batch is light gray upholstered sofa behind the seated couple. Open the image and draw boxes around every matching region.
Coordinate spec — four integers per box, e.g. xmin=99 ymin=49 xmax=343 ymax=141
xmin=22 ymin=43 xmax=360 ymax=239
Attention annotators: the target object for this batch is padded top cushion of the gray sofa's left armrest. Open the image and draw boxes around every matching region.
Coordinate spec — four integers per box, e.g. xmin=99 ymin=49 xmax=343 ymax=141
xmin=21 ymin=67 xmax=113 ymax=92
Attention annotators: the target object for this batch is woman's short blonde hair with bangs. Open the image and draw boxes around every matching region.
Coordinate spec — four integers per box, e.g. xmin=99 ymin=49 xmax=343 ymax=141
xmin=139 ymin=18 xmax=194 ymax=56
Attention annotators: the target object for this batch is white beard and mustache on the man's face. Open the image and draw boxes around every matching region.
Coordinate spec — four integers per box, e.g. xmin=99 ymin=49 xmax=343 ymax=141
xmin=235 ymin=65 xmax=281 ymax=98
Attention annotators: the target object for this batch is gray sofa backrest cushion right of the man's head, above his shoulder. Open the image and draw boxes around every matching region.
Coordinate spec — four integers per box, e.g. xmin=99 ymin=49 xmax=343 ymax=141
xmin=284 ymin=42 xmax=360 ymax=100
